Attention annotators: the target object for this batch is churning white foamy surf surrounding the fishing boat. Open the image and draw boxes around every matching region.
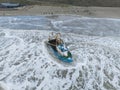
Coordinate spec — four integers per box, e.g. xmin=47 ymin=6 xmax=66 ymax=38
xmin=0 ymin=15 xmax=120 ymax=90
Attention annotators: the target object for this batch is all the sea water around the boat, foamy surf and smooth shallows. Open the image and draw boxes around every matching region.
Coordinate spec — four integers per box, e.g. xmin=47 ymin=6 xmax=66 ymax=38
xmin=0 ymin=15 xmax=120 ymax=90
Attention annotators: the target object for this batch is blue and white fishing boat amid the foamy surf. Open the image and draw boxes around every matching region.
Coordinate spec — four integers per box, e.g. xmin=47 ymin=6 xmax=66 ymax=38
xmin=46 ymin=33 xmax=73 ymax=63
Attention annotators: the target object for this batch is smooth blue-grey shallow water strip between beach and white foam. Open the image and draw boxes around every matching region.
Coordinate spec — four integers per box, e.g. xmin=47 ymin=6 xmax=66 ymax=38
xmin=0 ymin=15 xmax=120 ymax=36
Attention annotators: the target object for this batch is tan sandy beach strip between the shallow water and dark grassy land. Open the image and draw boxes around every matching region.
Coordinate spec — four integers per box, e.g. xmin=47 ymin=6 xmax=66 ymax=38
xmin=0 ymin=5 xmax=120 ymax=18
